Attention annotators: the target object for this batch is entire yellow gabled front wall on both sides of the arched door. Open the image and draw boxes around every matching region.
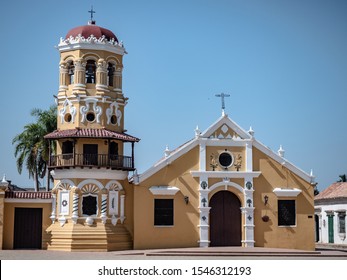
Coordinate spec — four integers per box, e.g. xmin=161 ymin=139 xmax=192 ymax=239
xmin=134 ymin=143 xmax=314 ymax=250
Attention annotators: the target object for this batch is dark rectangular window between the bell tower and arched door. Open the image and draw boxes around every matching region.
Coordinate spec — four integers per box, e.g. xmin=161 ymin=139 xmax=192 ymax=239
xmin=154 ymin=199 xmax=174 ymax=226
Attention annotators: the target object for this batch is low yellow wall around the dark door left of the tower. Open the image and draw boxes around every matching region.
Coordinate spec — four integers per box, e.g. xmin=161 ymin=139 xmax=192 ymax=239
xmin=3 ymin=202 xmax=52 ymax=249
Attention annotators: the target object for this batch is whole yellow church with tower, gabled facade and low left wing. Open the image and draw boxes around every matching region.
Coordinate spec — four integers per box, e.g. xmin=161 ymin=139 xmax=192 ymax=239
xmin=0 ymin=16 xmax=315 ymax=251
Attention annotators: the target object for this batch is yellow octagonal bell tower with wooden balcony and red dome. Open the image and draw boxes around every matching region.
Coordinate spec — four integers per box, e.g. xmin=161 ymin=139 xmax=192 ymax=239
xmin=45 ymin=15 xmax=139 ymax=251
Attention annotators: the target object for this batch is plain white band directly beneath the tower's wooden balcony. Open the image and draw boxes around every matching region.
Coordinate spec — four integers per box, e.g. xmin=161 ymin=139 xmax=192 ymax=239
xmin=51 ymin=167 xmax=128 ymax=180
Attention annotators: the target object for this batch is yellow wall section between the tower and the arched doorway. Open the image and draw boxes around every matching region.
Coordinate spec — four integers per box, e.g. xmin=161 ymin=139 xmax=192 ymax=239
xmin=134 ymin=147 xmax=199 ymax=249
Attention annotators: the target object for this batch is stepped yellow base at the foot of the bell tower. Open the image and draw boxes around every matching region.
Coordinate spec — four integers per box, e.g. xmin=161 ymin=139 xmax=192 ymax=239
xmin=47 ymin=222 xmax=133 ymax=252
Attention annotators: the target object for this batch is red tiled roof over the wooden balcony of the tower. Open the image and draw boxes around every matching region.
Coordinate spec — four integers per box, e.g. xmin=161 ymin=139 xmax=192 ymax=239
xmin=45 ymin=128 xmax=140 ymax=142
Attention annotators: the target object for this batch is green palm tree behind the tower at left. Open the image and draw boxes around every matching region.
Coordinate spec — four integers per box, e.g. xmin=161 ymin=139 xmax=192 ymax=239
xmin=12 ymin=106 xmax=56 ymax=191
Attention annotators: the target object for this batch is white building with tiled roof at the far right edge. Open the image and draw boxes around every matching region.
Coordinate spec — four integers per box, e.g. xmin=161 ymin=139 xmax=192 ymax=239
xmin=314 ymin=182 xmax=347 ymax=244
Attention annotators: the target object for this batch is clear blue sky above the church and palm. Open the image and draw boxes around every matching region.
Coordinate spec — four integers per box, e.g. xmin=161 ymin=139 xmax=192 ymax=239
xmin=0 ymin=0 xmax=347 ymax=190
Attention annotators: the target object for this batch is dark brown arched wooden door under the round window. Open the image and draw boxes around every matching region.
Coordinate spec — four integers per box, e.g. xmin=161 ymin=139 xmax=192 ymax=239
xmin=210 ymin=191 xmax=241 ymax=246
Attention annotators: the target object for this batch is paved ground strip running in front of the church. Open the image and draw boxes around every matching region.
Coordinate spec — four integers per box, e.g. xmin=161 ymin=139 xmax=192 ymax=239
xmin=0 ymin=243 xmax=347 ymax=260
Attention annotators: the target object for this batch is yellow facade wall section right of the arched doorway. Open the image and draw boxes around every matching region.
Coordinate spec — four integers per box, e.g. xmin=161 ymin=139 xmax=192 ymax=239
xmin=253 ymin=148 xmax=315 ymax=250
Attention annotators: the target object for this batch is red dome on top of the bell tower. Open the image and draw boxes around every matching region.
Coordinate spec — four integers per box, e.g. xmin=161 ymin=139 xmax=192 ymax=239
xmin=65 ymin=24 xmax=118 ymax=42
